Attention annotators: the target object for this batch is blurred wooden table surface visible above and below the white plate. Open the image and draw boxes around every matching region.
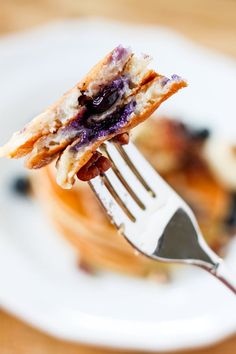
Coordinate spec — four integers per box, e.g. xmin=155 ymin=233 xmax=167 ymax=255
xmin=0 ymin=0 xmax=236 ymax=354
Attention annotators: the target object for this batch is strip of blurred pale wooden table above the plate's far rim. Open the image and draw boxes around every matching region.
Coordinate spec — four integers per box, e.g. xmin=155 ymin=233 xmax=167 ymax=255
xmin=0 ymin=0 xmax=236 ymax=55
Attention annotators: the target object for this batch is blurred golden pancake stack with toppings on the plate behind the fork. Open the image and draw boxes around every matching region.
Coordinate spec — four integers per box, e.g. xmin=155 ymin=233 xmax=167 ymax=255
xmin=32 ymin=117 xmax=236 ymax=281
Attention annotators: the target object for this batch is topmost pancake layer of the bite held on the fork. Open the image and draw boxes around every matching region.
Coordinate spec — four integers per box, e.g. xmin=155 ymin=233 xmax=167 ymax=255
xmin=0 ymin=46 xmax=132 ymax=158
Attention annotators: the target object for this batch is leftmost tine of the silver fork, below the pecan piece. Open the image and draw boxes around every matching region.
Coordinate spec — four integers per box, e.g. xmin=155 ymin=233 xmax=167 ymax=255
xmin=88 ymin=176 xmax=132 ymax=229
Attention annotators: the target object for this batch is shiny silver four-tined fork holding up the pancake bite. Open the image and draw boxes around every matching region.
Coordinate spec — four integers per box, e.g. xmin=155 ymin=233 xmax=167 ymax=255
xmin=89 ymin=142 xmax=236 ymax=294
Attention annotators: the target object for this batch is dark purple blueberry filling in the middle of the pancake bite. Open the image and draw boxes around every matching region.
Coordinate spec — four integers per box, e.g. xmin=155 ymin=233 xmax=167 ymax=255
xmin=63 ymin=76 xmax=136 ymax=151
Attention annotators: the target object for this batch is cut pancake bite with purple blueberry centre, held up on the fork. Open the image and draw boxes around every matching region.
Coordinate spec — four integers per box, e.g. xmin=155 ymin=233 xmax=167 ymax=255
xmin=0 ymin=46 xmax=186 ymax=189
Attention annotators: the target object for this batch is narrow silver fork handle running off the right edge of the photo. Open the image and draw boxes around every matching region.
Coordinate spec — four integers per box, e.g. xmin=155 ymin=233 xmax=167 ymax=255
xmin=200 ymin=260 xmax=236 ymax=295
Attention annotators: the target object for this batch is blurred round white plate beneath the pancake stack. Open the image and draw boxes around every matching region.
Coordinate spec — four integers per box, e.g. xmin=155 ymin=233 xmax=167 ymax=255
xmin=0 ymin=20 xmax=236 ymax=350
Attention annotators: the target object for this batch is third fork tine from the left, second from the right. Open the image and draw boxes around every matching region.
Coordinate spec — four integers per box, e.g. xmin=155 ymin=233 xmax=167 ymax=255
xmin=101 ymin=142 xmax=155 ymax=205
